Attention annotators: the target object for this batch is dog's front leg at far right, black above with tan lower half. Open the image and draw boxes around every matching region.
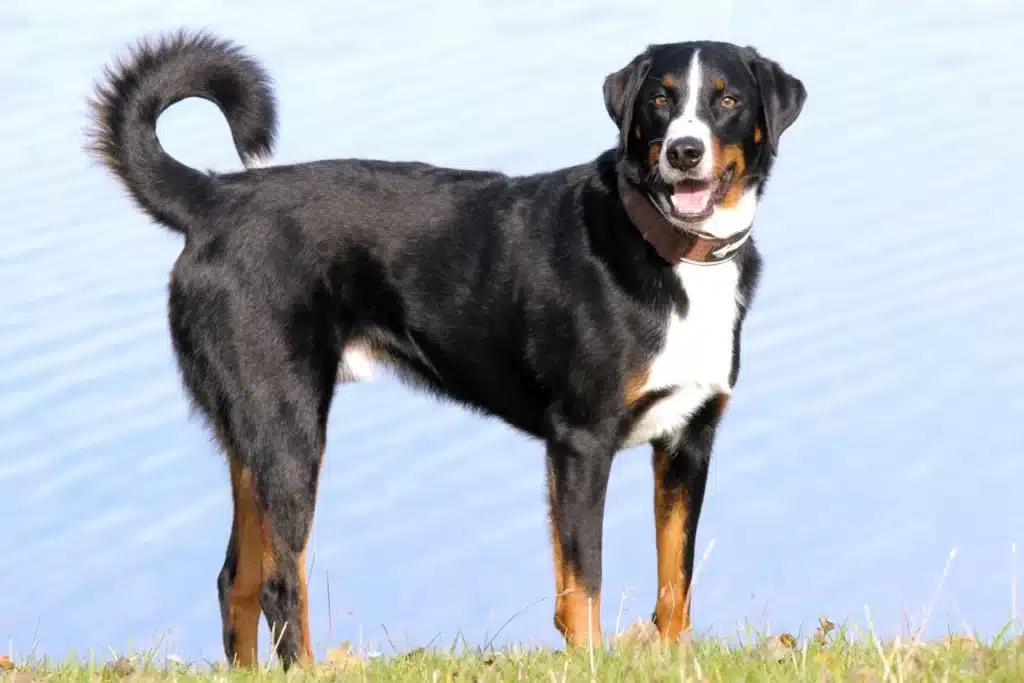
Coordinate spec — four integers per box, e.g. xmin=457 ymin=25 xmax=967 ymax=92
xmin=651 ymin=394 xmax=727 ymax=643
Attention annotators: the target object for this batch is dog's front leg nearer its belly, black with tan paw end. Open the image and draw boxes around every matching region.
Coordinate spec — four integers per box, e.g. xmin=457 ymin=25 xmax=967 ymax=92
xmin=548 ymin=413 xmax=614 ymax=645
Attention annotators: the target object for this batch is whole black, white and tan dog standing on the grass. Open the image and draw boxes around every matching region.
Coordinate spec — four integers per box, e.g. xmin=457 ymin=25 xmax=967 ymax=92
xmin=88 ymin=31 xmax=807 ymax=668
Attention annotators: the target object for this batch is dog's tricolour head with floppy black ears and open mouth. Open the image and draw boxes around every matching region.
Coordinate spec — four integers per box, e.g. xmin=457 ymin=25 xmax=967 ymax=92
xmin=604 ymin=42 xmax=807 ymax=238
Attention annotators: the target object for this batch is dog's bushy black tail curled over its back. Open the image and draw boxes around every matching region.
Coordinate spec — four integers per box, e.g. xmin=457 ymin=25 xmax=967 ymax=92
xmin=88 ymin=31 xmax=276 ymax=232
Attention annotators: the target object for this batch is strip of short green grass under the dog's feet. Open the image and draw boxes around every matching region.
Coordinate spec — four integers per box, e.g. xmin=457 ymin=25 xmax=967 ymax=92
xmin=0 ymin=620 xmax=1024 ymax=683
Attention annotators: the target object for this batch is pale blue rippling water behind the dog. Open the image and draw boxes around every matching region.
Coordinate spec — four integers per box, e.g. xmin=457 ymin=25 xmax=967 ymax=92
xmin=0 ymin=0 xmax=1024 ymax=659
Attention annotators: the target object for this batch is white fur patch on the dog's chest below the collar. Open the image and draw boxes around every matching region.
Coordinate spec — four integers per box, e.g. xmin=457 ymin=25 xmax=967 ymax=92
xmin=623 ymin=261 xmax=739 ymax=447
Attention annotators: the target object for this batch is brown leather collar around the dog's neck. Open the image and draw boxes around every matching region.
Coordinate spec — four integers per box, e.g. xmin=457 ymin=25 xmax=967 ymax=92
xmin=618 ymin=174 xmax=753 ymax=265
